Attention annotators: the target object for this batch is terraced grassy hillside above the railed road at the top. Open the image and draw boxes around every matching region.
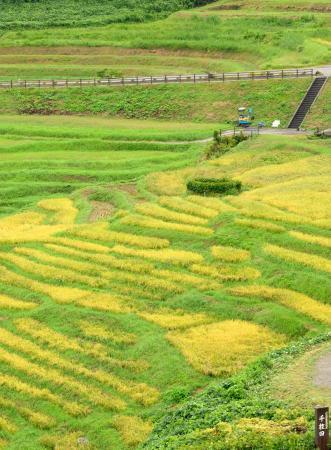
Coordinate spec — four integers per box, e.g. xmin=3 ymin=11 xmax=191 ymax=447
xmin=0 ymin=0 xmax=330 ymax=78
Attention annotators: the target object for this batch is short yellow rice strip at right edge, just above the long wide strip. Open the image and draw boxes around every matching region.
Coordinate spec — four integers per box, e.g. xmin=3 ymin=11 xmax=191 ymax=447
xmin=264 ymin=244 xmax=331 ymax=273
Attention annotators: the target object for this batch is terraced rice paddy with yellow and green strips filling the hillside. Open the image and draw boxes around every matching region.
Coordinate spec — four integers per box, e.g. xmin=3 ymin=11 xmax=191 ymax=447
xmin=0 ymin=121 xmax=331 ymax=449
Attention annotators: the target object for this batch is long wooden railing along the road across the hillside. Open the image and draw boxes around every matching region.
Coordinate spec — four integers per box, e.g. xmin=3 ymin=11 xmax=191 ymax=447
xmin=0 ymin=69 xmax=317 ymax=89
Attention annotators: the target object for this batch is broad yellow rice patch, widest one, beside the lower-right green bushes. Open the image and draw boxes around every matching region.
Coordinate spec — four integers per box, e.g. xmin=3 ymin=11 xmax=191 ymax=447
xmin=167 ymin=320 xmax=285 ymax=376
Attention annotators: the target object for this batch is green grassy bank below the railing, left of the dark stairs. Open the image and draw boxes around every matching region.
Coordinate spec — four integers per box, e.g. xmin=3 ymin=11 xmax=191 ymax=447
xmin=0 ymin=79 xmax=311 ymax=126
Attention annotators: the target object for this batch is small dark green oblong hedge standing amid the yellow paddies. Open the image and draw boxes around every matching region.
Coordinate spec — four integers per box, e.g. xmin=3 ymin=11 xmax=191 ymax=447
xmin=187 ymin=178 xmax=242 ymax=195
